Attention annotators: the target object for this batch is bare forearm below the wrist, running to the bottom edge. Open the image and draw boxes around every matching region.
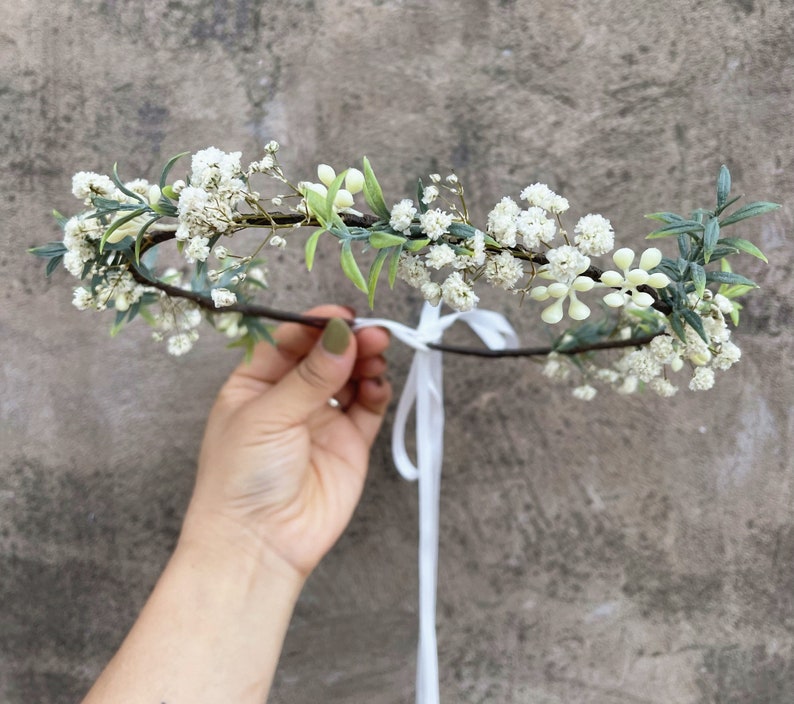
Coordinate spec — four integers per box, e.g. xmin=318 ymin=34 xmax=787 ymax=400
xmin=84 ymin=538 xmax=302 ymax=704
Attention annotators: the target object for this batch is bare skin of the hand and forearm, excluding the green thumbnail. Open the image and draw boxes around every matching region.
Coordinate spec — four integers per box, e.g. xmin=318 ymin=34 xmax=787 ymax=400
xmin=84 ymin=306 xmax=391 ymax=704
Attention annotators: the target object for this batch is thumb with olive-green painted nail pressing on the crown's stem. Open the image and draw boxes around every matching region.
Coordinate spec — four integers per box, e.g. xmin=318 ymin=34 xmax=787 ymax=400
xmin=255 ymin=318 xmax=356 ymax=425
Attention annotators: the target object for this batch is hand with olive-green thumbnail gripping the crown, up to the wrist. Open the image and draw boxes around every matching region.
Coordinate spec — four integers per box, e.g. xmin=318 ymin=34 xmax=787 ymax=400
xmin=181 ymin=306 xmax=391 ymax=579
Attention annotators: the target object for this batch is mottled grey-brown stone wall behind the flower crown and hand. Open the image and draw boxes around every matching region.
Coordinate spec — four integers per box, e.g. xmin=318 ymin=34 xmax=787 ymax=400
xmin=0 ymin=0 xmax=794 ymax=704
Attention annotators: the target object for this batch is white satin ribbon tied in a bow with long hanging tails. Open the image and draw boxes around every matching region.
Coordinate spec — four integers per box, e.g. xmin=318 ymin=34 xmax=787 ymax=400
xmin=355 ymin=303 xmax=518 ymax=704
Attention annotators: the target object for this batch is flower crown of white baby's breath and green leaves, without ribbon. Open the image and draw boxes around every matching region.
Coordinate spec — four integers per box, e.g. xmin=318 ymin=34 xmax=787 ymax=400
xmin=31 ymin=142 xmax=779 ymax=400
